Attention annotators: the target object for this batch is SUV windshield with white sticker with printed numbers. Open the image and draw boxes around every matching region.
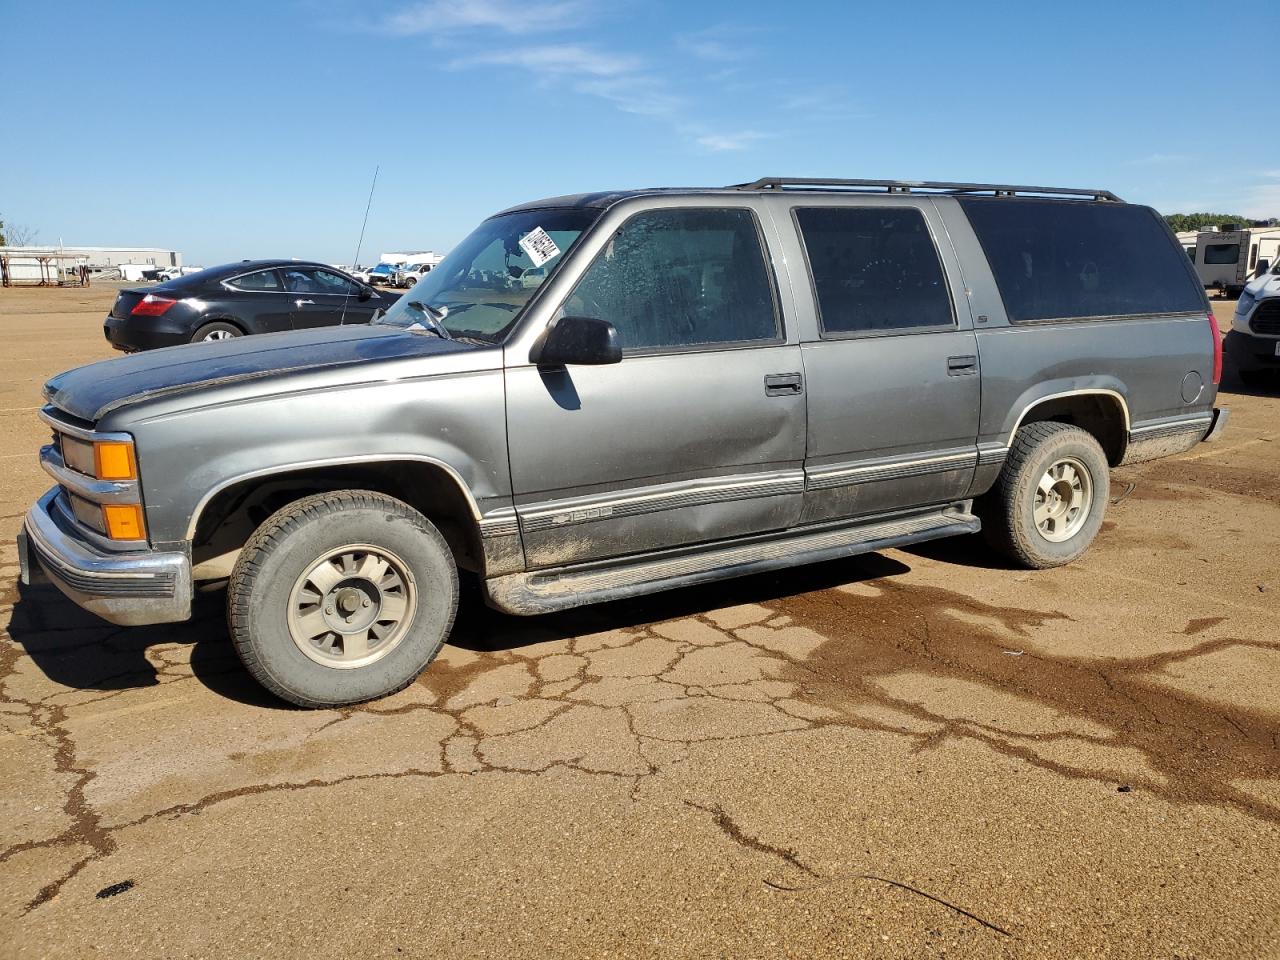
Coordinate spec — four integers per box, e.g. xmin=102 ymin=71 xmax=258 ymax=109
xmin=375 ymin=210 xmax=599 ymax=340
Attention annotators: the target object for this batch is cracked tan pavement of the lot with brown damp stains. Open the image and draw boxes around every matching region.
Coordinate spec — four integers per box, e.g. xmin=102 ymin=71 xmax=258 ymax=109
xmin=0 ymin=288 xmax=1280 ymax=959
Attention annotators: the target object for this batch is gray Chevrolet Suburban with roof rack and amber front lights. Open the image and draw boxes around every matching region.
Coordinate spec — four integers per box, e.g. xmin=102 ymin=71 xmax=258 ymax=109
xmin=19 ymin=179 xmax=1226 ymax=707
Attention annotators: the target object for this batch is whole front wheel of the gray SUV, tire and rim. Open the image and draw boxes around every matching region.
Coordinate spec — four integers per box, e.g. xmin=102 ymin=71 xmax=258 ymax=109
xmin=227 ymin=490 xmax=458 ymax=707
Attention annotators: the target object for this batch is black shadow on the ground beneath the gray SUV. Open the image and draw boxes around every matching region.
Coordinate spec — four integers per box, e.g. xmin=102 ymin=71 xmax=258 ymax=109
xmin=6 ymin=553 xmax=910 ymax=709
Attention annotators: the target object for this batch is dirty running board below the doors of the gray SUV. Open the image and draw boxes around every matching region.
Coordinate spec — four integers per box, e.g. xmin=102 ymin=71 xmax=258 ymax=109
xmin=484 ymin=502 xmax=982 ymax=616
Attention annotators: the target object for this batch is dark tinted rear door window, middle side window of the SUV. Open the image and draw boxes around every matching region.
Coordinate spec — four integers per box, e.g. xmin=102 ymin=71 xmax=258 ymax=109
xmin=795 ymin=207 xmax=952 ymax=333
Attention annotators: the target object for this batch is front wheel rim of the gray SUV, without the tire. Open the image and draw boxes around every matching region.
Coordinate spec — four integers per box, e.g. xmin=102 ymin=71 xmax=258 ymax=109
xmin=288 ymin=544 xmax=417 ymax=669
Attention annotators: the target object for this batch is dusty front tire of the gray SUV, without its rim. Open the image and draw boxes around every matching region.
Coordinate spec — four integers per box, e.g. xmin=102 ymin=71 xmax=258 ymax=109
xmin=227 ymin=490 xmax=458 ymax=707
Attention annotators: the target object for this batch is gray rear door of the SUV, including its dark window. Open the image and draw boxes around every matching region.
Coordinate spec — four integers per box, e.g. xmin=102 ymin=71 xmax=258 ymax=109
xmin=787 ymin=197 xmax=982 ymax=522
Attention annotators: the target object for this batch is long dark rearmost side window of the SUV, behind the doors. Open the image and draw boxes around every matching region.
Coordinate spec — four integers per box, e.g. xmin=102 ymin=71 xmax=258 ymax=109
xmin=960 ymin=197 xmax=1204 ymax=323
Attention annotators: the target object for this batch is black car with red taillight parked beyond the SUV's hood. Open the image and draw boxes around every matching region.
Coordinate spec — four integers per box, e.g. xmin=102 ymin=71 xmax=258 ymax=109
xmin=102 ymin=260 xmax=398 ymax=352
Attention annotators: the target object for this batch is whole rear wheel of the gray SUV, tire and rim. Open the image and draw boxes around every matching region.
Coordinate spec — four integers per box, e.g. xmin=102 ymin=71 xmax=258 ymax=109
xmin=980 ymin=422 xmax=1111 ymax=570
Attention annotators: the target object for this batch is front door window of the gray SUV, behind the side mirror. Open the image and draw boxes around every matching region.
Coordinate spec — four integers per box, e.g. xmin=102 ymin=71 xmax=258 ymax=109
xmin=564 ymin=210 xmax=778 ymax=349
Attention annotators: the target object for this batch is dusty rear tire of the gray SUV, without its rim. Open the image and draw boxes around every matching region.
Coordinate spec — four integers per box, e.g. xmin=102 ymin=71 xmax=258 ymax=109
xmin=979 ymin=422 xmax=1111 ymax=570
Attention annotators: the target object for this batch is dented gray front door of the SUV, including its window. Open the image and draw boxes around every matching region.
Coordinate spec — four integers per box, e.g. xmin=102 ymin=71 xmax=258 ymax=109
xmin=507 ymin=207 xmax=805 ymax=567
